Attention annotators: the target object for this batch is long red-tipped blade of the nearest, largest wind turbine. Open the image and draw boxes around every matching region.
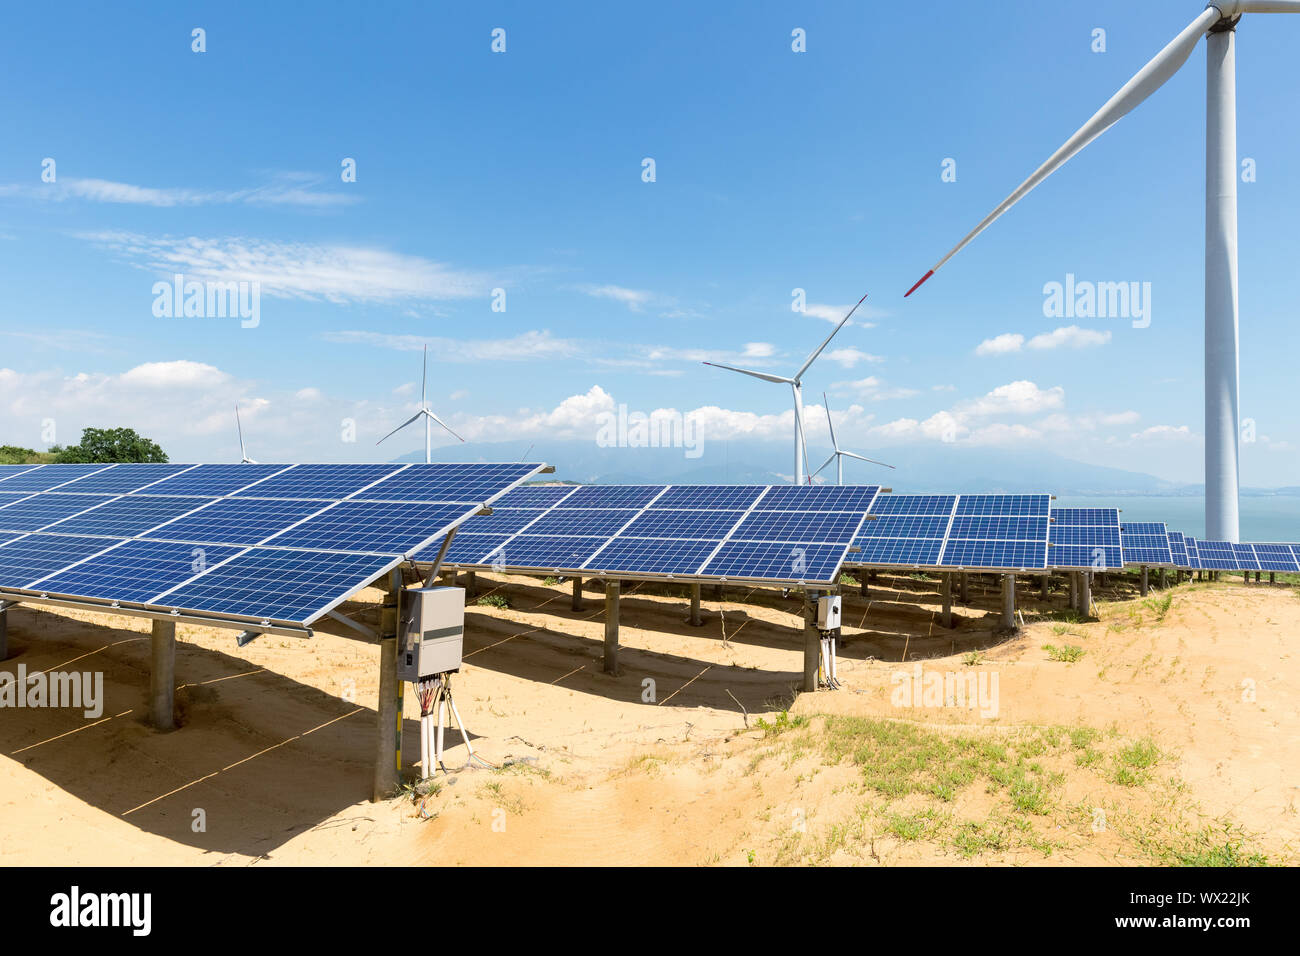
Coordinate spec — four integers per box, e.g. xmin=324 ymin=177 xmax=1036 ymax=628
xmin=904 ymin=7 xmax=1223 ymax=298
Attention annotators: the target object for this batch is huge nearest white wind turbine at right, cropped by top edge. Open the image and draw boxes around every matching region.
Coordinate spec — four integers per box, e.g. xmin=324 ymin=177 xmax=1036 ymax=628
xmin=904 ymin=0 xmax=1300 ymax=541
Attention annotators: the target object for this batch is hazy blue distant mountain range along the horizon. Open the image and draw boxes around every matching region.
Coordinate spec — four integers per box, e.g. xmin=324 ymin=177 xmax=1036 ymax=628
xmin=394 ymin=441 xmax=1300 ymax=497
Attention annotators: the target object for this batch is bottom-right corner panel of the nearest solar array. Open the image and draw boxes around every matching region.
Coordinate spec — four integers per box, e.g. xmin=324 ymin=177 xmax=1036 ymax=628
xmin=153 ymin=548 xmax=398 ymax=624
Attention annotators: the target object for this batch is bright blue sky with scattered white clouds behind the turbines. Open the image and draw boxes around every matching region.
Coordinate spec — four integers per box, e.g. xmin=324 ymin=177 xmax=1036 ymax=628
xmin=0 ymin=3 xmax=1300 ymax=490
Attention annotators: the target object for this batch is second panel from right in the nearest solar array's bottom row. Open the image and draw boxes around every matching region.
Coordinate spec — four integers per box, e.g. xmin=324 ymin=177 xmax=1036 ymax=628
xmin=30 ymin=540 xmax=239 ymax=604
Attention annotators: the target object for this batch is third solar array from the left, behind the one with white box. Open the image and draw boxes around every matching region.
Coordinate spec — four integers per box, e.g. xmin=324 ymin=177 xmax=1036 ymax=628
xmin=849 ymin=494 xmax=1052 ymax=571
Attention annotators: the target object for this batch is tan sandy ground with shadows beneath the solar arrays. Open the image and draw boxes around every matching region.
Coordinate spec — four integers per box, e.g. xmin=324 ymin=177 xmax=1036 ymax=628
xmin=0 ymin=575 xmax=1300 ymax=865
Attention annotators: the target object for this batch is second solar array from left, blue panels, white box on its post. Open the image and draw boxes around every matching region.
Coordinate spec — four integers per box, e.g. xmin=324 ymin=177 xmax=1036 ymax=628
xmin=416 ymin=485 xmax=880 ymax=587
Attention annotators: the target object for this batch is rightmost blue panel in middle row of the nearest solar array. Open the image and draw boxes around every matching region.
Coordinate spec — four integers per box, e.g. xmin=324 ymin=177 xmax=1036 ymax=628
xmin=263 ymin=501 xmax=465 ymax=555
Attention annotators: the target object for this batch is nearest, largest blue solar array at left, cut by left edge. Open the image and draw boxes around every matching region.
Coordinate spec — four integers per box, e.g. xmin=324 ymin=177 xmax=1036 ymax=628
xmin=0 ymin=464 xmax=543 ymax=626
